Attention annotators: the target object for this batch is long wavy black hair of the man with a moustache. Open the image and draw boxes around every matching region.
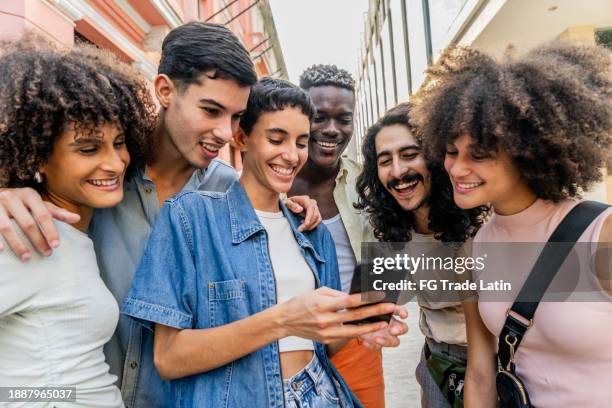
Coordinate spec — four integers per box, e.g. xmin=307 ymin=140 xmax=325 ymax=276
xmin=354 ymin=103 xmax=488 ymax=242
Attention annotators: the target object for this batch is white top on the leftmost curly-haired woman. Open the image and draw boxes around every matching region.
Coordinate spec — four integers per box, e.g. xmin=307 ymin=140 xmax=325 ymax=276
xmin=0 ymin=222 xmax=123 ymax=408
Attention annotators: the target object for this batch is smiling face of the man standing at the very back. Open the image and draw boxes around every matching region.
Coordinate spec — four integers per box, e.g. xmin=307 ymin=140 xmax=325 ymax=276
xmin=308 ymin=85 xmax=355 ymax=168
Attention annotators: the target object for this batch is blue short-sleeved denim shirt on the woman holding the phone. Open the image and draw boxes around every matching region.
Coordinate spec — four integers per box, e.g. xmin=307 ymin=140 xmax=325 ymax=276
xmin=122 ymin=182 xmax=361 ymax=408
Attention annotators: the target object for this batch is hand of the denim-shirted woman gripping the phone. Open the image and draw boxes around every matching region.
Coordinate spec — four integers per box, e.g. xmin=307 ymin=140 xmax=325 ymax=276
xmin=275 ymin=287 xmax=397 ymax=344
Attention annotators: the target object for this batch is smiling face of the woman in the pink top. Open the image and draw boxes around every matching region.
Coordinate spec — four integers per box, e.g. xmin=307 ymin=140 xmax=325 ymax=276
xmin=444 ymin=135 xmax=535 ymax=213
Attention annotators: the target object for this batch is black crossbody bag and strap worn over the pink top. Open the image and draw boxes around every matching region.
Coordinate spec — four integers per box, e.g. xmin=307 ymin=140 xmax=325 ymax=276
xmin=495 ymin=201 xmax=608 ymax=408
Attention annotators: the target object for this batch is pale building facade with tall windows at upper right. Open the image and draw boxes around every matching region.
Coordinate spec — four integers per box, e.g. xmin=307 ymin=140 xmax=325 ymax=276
xmin=349 ymin=0 xmax=612 ymax=203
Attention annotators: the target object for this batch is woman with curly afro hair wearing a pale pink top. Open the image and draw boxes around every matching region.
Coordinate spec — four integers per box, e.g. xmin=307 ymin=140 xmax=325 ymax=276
xmin=412 ymin=43 xmax=612 ymax=408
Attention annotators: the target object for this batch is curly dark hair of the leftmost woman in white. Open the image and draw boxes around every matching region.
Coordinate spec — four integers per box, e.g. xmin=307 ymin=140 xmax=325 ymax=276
xmin=0 ymin=33 xmax=156 ymax=188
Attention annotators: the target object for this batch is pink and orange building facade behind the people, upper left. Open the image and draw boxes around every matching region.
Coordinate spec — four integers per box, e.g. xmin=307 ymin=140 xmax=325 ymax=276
xmin=0 ymin=0 xmax=270 ymax=168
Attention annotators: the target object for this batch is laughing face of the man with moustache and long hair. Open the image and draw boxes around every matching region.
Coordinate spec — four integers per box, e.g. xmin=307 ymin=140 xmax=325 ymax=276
xmin=375 ymin=124 xmax=431 ymax=211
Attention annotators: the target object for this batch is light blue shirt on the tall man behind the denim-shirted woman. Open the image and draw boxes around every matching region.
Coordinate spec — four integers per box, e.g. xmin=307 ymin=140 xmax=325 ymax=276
xmin=88 ymin=159 xmax=238 ymax=408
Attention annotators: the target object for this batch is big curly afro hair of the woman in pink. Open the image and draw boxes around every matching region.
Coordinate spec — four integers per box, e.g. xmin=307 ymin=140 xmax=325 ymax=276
xmin=411 ymin=42 xmax=612 ymax=202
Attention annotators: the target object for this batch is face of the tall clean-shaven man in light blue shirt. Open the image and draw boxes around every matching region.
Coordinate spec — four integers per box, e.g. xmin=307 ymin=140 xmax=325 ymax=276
xmin=160 ymin=74 xmax=251 ymax=168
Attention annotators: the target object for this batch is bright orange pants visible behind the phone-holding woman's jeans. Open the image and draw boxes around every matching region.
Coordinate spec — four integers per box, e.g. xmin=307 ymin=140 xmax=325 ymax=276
xmin=331 ymin=339 xmax=385 ymax=408
